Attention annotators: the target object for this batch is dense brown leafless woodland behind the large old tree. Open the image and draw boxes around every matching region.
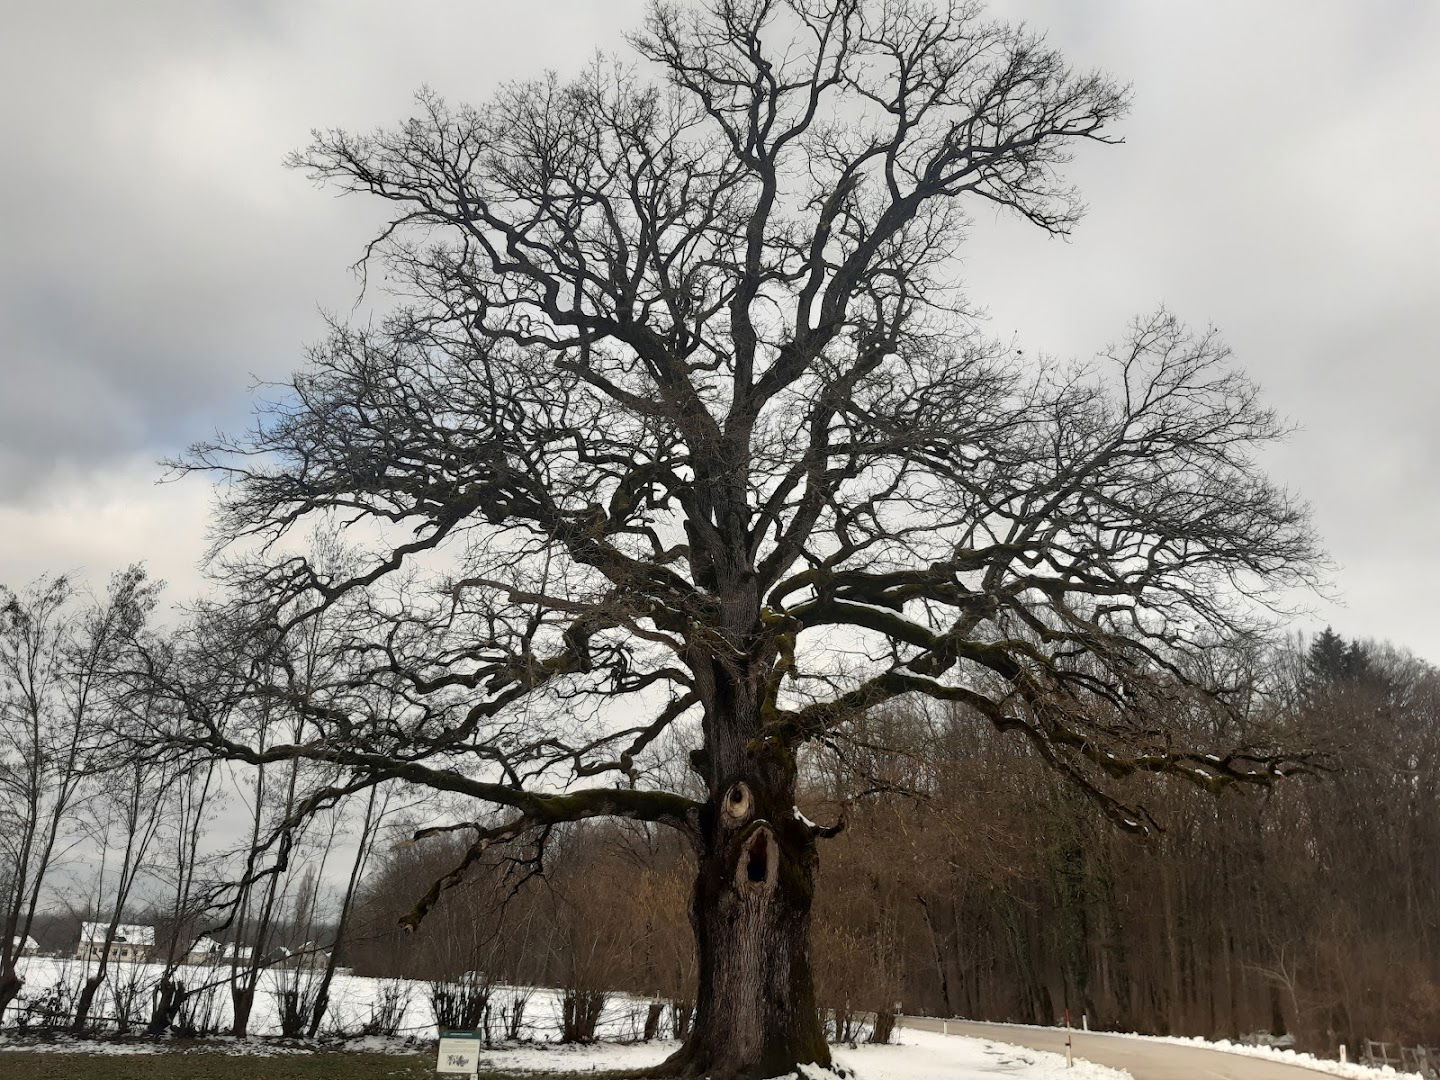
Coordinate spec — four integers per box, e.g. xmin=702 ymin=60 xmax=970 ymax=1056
xmin=350 ymin=632 xmax=1440 ymax=1051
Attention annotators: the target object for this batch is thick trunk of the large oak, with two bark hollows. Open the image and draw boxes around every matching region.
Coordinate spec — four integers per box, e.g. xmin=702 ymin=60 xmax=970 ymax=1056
xmin=655 ymin=776 xmax=829 ymax=1080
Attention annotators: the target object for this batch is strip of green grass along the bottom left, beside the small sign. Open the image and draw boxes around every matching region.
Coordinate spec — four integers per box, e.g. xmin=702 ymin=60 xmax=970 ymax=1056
xmin=0 ymin=1050 xmax=543 ymax=1080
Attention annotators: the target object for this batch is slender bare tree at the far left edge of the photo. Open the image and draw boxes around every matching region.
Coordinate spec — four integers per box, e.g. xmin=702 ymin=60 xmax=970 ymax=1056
xmin=0 ymin=567 xmax=156 ymax=1015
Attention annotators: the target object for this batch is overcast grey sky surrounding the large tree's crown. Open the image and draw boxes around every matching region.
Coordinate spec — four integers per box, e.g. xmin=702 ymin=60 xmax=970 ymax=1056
xmin=0 ymin=0 xmax=1440 ymax=662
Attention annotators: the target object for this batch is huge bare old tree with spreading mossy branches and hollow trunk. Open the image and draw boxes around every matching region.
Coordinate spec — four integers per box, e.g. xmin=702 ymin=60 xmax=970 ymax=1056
xmin=168 ymin=0 xmax=1316 ymax=1077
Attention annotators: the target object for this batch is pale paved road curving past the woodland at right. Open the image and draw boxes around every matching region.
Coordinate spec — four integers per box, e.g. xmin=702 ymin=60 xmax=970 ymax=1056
xmin=901 ymin=1017 xmax=1342 ymax=1080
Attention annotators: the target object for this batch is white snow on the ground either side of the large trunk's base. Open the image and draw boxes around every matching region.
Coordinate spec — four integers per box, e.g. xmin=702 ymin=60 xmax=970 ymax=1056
xmin=466 ymin=1030 xmax=1130 ymax=1080
